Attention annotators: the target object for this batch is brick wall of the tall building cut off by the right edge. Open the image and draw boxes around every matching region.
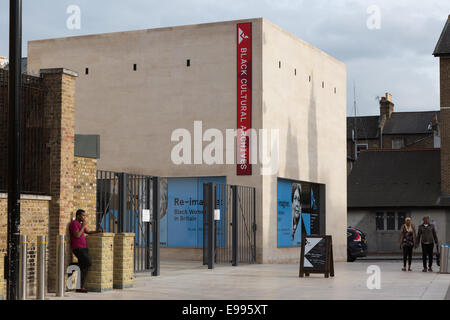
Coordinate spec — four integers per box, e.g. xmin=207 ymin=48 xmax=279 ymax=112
xmin=439 ymin=56 xmax=450 ymax=194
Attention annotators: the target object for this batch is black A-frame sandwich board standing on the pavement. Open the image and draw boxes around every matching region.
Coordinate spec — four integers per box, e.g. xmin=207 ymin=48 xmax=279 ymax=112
xmin=299 ymin=235 xmax=334 ymax=278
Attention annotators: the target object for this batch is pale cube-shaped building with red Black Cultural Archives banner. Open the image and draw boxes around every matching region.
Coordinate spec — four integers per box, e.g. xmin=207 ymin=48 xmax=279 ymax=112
xmin=28 ymin=18 xmax=347 ymax=263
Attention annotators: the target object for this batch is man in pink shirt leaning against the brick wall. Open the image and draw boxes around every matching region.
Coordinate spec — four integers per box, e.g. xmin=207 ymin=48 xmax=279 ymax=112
xmin=69 ymin=209 xmax=103 ymax=293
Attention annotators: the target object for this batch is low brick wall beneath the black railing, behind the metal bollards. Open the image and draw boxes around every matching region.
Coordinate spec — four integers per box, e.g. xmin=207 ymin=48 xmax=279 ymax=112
xmin=0 ymin=194 xmax=51 ymax=296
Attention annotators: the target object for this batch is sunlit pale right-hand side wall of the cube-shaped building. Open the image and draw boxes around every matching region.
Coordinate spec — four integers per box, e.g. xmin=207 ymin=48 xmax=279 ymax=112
xmin=263 ymin=20 xmax=347 ymax=262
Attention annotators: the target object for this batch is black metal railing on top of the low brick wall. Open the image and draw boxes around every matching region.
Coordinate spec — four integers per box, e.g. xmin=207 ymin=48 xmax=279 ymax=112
xmin=0 ymin=69 xmax=48 ymax=194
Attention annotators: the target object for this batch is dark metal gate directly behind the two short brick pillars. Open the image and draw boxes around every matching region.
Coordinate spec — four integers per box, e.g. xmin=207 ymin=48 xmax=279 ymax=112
xmin=97 ymin=170 xmax=160 ymax=276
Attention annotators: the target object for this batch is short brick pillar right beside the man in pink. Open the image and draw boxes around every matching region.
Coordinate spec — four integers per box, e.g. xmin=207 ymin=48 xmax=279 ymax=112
xmin=85 ymin=233 xmax=114 ymax=292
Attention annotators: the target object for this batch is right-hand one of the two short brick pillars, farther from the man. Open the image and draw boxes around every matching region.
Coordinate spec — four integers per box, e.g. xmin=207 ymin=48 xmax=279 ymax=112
xmin=113 ymin=233 xmax=135 ymax=289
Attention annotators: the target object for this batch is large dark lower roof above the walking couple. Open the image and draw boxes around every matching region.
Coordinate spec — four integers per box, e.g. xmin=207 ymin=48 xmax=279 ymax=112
xmin=347 ymin=149 xmax=450 ymax=208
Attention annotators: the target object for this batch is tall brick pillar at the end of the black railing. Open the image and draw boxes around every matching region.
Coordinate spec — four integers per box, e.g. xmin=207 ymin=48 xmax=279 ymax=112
xmin=40 ymin=69 xmax=77 ymax=292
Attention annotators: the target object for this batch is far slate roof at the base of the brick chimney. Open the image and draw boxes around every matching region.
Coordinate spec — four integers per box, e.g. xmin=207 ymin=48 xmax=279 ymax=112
xmin=347 ymin=111 xmax=440 ymax=140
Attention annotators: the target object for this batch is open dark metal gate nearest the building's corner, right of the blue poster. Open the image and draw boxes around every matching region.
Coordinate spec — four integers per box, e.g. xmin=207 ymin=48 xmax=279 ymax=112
xmin=203 ymin=183 xmax=256 ymax=269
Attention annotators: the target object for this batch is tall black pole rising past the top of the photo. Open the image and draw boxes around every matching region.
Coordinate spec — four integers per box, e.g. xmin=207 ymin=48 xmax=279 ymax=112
xmin=7 ymin=0 xmax=22 ymax=300
